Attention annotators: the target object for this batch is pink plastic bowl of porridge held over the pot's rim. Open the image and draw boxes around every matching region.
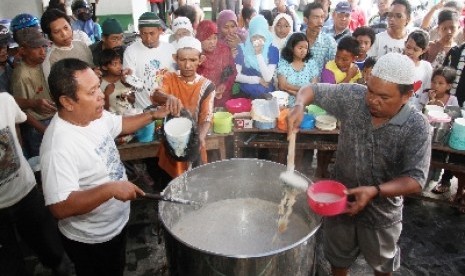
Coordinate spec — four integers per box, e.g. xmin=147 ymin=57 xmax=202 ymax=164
xmin=307 ymin=180 xmax=347 ymax=216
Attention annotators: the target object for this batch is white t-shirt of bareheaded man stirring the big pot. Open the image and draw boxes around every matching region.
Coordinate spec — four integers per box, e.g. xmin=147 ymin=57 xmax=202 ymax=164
xmin=40 ymin=111 xmax=129 ymax=243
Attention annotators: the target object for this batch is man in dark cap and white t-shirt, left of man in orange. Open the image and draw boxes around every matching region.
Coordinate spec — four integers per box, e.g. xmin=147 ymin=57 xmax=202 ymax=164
xmin=123 ymin=12 xmax=175 ymax=109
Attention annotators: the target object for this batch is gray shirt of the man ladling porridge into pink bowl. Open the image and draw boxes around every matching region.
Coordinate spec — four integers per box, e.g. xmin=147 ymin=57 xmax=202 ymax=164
xmin=312 ymin=84 xmax=431 ymax=228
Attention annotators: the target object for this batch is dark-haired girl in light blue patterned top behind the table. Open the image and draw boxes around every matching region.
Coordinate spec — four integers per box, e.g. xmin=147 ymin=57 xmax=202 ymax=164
xmin=278 ymin=33 xmax=319 ymax=107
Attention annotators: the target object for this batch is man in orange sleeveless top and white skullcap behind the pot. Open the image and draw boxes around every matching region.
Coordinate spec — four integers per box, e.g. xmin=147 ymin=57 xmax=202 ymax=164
xmin=152 ymin=36 xmax=215 ymax=181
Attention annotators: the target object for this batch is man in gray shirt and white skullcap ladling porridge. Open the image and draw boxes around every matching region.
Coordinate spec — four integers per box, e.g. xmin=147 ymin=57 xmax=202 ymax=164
xmin=288 ymin=53 xmax=431 ymax=275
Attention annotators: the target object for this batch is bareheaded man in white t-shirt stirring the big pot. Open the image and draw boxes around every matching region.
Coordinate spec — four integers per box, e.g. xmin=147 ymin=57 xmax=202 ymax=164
xmin=40 ymin=59 xmax=168 ymax=276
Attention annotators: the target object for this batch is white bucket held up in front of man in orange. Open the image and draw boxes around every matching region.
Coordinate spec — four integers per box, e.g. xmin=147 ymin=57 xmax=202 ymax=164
xmin=164 ymin=118 xmax=192 ymax=157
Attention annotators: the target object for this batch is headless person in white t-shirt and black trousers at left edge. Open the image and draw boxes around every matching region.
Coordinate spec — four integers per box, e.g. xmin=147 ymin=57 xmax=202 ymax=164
xmin=0 ymin=92 xmax=71 ymax=275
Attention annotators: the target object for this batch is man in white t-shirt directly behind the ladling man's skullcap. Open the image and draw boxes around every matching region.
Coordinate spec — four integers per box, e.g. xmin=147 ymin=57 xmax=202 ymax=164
xmin=367 ymin=0 xmax=412 ymax=58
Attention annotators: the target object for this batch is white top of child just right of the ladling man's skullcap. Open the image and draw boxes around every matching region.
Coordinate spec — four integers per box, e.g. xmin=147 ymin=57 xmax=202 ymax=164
xmin=409 ymin=60 xmax=433 ymax=111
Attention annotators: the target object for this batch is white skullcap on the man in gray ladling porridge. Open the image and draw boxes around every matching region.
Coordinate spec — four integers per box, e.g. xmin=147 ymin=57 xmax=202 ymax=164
xmin=371 ymin=53 xmax=415 ymax=84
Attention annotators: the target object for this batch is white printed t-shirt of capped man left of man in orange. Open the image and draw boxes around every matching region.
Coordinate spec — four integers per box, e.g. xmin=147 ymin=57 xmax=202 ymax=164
xmin=123 ymin=40 xmax=175 ymax=109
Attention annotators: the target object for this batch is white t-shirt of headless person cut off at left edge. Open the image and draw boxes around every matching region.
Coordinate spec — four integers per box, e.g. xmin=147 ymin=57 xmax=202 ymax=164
xmin=0 ymin=92 xmax=36 ymax=209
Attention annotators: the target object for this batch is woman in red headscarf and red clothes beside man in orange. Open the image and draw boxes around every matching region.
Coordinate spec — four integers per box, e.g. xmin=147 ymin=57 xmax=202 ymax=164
xmin=196 ymin=20 xmax=237 ymax=107
